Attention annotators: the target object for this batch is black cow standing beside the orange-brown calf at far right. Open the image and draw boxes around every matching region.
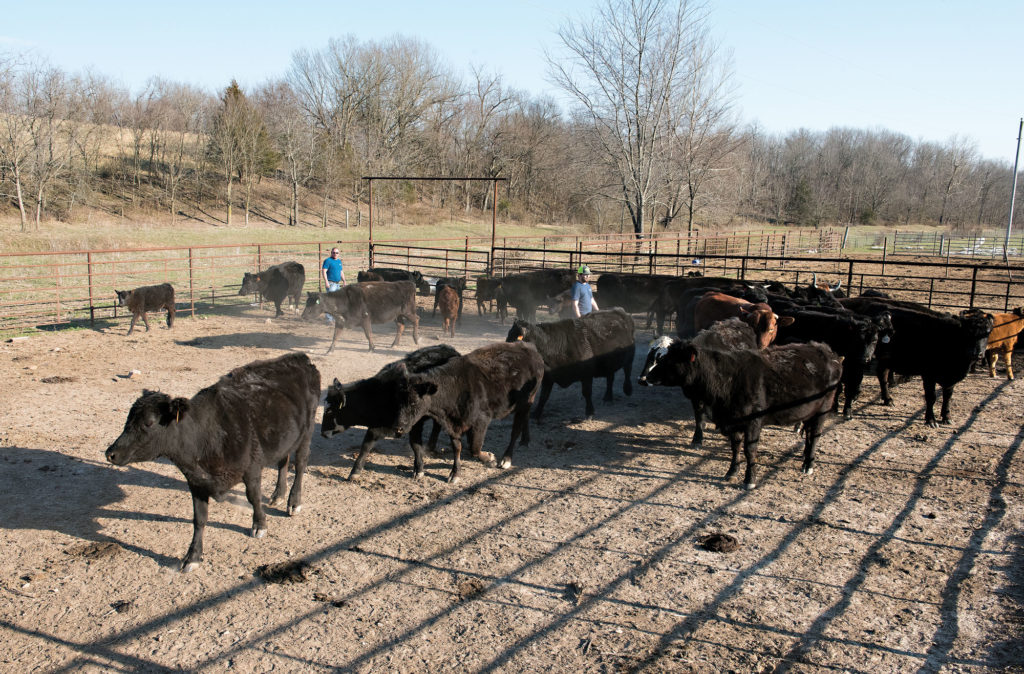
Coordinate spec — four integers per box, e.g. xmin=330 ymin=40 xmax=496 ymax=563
xmin=841 ymin=297 xmax=994 ymax=427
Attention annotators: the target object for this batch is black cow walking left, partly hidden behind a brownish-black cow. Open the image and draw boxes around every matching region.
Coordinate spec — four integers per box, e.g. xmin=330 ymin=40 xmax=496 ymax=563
xmin=321 ymin=344 xmax=459 ymax=479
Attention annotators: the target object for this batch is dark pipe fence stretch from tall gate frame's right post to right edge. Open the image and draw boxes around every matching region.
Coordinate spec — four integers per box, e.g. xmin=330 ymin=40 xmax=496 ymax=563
xmin=494 ymin=247 xmax=1024 ymax=311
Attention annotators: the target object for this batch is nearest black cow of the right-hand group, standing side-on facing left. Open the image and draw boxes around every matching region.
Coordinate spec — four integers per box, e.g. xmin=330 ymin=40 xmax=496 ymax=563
xmin=647 ymin=342 xmax=842 ymax=489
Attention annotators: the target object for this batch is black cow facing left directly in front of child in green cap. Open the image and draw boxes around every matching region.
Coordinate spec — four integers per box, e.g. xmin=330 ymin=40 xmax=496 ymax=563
xmin=505 ymin=308 xmax=636 ymax=419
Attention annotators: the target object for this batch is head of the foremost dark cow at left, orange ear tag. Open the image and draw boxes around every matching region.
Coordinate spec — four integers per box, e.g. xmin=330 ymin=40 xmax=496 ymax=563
xmin=106 ymin=390 xmax=189 ymax=466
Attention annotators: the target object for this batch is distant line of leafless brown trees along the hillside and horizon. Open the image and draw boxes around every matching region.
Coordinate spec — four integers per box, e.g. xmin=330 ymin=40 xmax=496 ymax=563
xmin=0 ymin=44 xmax=1012 ymax=231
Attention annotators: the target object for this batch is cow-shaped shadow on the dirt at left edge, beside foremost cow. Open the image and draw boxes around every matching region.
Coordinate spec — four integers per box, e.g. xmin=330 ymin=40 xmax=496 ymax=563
xmin=0 ymin=447 xmax=260 ymax=567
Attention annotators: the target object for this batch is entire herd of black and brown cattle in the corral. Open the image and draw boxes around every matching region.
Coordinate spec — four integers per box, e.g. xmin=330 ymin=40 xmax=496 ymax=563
xmin=106 ymin=262 xmax=1024 ymax=571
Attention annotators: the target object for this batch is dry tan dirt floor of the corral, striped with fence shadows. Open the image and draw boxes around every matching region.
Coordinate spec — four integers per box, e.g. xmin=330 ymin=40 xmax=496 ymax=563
xmin=0 ymin=300 xmax=1024 ymax=672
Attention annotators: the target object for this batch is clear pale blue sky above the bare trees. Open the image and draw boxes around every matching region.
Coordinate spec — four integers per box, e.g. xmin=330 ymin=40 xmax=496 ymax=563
xmin=0 ymin=0 xmax=1024 ymax=163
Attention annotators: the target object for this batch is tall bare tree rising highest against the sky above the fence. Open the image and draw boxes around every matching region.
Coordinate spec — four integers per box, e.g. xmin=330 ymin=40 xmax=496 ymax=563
xmin=548 ymin=0 xmax=706 ymax=238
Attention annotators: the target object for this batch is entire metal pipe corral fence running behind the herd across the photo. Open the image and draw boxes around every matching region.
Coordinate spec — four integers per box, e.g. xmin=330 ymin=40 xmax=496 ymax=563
xmin=6 ymin=228 xmax=1024 ymax=333
